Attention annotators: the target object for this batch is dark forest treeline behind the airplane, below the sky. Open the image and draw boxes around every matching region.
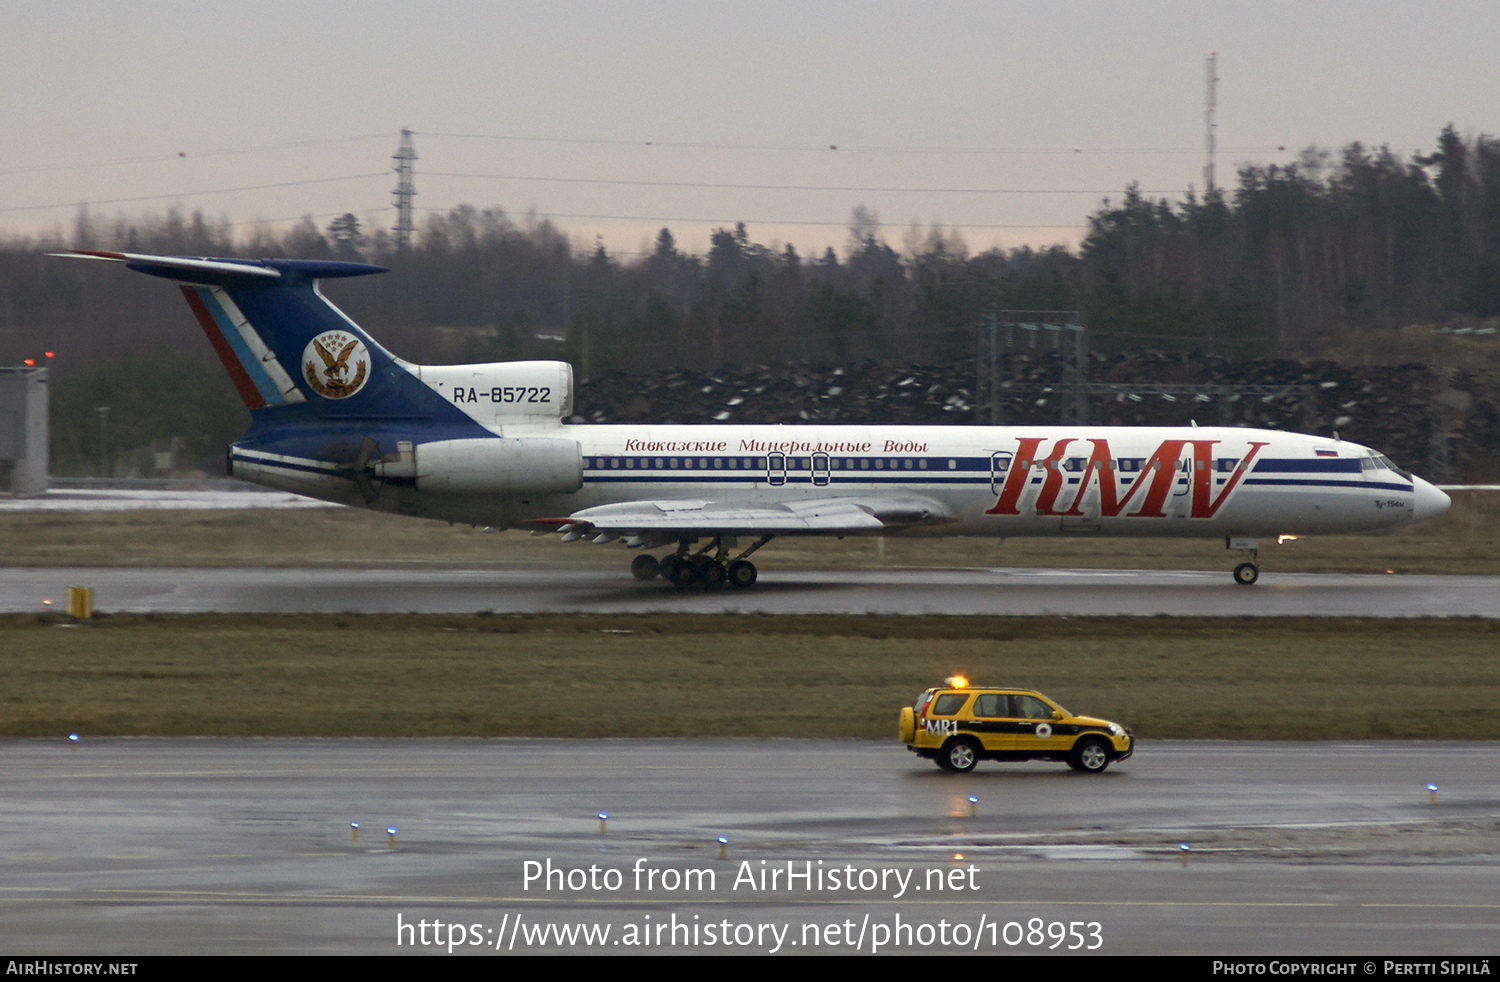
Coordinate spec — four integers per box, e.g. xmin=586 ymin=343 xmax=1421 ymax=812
xmin=0 ymin=126 xmax=1500 ymax=476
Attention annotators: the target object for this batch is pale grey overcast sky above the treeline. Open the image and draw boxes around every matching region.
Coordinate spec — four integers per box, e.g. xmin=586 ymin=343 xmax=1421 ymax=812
xmin=0 ymin=0 xmax=1500 ymax=255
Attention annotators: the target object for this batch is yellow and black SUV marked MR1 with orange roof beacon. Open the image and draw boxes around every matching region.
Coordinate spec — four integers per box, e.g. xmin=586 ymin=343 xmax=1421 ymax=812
xmin=900 ymin=678 xmax=1136 ymax=774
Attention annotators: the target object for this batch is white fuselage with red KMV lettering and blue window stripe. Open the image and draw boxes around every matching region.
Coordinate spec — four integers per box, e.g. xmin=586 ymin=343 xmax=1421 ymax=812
xmin=236 ymin=423 xmax=1449 ymax=538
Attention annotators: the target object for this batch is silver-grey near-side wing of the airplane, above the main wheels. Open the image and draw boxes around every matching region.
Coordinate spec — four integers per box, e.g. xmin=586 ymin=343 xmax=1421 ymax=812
xmin=531 ymin=498 xmax=953 ymax=540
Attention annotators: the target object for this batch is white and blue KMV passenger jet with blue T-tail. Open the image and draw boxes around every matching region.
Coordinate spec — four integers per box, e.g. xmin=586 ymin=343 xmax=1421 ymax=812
xmin=51 ymin=250 xmax=1451 ymax=589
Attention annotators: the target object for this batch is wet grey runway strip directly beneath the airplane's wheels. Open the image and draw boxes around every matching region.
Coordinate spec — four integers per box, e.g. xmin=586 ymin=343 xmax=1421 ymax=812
xmin=0 ymin=567 xmax=1500 ymax=618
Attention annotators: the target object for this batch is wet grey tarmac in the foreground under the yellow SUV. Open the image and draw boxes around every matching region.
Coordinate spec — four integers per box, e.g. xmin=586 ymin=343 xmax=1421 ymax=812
xmin=0 ymin=735 xmax=1500 ymax=955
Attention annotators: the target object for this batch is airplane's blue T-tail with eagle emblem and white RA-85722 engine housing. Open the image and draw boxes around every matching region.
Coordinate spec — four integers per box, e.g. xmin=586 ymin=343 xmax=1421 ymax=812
xmin=54 ymin=250 xmax=578 ymax=504
